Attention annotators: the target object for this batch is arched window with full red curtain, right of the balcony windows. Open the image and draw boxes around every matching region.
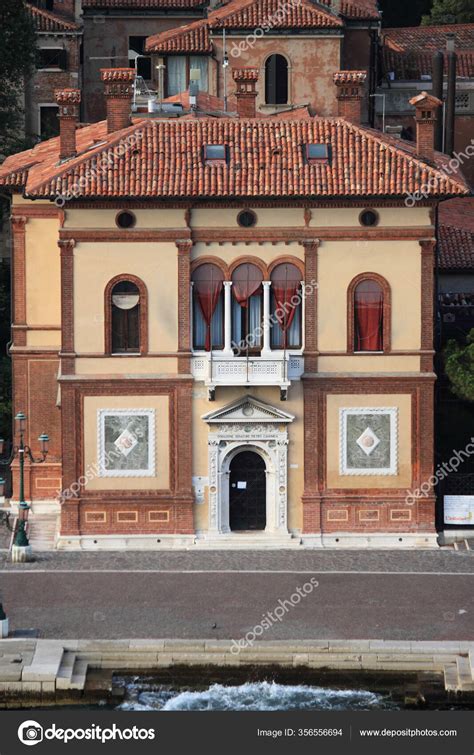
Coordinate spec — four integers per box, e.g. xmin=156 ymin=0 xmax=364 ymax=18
xmin=354 ymin=279 xmax=383 ymax=351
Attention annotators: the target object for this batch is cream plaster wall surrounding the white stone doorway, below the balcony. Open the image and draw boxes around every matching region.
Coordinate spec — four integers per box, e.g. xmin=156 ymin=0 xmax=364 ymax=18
xmin=193 ymin=382 xmax=304 ymax=531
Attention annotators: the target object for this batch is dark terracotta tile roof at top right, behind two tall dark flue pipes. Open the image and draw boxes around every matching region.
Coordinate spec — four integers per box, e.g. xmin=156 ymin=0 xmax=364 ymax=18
xmin=383 ymin=24 xmax=474 ymax=80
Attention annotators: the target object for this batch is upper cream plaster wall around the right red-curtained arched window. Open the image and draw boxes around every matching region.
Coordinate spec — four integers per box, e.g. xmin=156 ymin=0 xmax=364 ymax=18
xmin=318 ymin=241 xmax=421 ymax=352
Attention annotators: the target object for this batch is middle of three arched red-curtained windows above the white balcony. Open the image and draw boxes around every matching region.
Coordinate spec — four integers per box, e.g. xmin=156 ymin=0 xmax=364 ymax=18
xmin=232 ymin=262 xmax=263 ymax=354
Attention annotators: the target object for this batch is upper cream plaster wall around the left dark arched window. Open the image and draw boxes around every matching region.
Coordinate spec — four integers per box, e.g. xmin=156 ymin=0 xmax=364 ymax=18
xmin=74 ymin=242 xmax=178 ymax=354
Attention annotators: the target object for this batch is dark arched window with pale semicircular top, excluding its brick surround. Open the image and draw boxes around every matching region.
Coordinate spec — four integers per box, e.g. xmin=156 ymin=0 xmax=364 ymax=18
xmin=111 ymin=281 xmax=140 ymax=354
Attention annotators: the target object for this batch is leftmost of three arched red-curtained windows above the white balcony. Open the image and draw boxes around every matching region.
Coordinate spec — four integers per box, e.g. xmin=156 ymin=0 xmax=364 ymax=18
xmin=192 ymin=263 xmax=224 ymax=351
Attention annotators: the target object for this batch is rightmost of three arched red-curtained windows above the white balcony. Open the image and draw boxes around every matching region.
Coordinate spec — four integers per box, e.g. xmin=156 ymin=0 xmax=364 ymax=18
xmin=270 ymin=262 xmax=303 ymax=349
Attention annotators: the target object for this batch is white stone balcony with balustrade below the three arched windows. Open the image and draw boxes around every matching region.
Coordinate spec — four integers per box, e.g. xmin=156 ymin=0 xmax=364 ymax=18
xmin=192 ymin=351 xmax=304 ymax=399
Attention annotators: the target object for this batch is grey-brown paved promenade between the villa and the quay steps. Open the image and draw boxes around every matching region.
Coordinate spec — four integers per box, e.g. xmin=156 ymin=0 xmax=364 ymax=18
xmin=0 ymin=551 xmax=474 ymax=641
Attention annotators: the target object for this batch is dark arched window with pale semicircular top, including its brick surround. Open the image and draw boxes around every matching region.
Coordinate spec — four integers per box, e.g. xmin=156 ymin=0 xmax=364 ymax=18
xmin=105 ymin=275 xmax=148 ymax=354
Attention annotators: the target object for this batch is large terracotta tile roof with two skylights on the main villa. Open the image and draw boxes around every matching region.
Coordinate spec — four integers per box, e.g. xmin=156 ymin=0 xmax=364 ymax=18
xmin=0 ymin=118 xmax=468 ymax=198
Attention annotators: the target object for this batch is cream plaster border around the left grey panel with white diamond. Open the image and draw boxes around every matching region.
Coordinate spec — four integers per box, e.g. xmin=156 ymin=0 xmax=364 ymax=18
xmin=84 ymin=395 xmax=170 ymax=490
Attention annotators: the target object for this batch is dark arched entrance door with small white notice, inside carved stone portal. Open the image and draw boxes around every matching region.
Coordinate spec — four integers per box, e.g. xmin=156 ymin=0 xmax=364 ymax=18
xmin=229 ymin=451 xmax=267 ymax=532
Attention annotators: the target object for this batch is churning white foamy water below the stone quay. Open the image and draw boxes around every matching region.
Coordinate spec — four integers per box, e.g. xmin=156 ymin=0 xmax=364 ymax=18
xmin=118 ymin=679 xmax=397 ymax=711
